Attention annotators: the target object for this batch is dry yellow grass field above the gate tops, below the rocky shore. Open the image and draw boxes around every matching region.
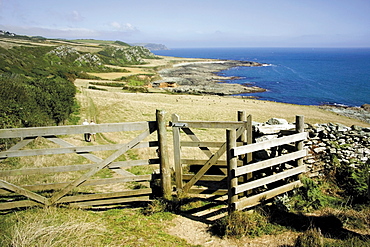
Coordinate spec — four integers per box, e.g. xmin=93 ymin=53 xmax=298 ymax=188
xmin=78 ymin=87 xmax=369 ymax=126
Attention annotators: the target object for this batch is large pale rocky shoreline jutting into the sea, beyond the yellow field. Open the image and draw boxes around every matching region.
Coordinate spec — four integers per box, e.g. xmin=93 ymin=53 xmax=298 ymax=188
xmin=153 ymin=60 xmax=266 ymax=95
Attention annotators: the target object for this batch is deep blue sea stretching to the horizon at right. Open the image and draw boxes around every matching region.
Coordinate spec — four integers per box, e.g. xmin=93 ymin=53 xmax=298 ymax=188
xmin=153 ymin=48 xmax=370 ymax=106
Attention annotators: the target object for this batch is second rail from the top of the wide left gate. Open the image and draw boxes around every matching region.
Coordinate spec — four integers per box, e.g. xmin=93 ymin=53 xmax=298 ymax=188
xmin=0 ymin=142 xmax=157 ymax=158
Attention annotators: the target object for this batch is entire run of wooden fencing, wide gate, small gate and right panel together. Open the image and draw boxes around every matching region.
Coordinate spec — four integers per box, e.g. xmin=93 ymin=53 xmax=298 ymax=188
xmin=0 ymin=110 xmax=306 ymax=212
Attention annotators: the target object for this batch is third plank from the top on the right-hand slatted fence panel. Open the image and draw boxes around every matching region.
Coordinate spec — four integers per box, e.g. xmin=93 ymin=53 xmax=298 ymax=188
xmin=235 ymin=166 xmax=306 ymax=194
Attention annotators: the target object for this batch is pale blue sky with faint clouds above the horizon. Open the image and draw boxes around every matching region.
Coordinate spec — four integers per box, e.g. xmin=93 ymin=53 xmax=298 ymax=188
xmin=0 ymin=0 xmax=370 ymax=48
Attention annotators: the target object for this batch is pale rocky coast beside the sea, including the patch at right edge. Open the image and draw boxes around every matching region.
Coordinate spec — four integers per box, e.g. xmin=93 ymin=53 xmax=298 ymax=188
xmin=153 ymin=57 xmax=370 ymax=124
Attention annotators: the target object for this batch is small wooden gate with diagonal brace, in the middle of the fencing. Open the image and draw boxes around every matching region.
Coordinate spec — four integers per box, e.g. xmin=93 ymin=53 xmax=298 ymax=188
xmin=171 ymin=111 xmax=252 ymax=195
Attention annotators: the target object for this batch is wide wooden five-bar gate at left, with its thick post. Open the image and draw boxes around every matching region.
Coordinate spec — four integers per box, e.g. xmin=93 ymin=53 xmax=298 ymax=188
xmin=0 ymin=110 xmax=171 ymax=210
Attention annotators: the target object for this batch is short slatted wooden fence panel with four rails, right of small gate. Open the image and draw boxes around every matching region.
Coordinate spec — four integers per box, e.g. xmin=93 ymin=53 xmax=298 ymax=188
xmin=227 ymin=116 xmax=307 ymax=212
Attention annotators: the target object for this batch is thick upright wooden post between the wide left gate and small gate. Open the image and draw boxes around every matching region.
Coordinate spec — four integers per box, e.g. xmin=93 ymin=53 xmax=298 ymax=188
xmin=156 ymin=109 xmax=171 ymax=199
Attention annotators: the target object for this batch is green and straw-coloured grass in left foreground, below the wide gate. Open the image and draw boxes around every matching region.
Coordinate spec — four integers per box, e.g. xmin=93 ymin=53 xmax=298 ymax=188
xmin=0 ymin=207 xmax=195 ymax=247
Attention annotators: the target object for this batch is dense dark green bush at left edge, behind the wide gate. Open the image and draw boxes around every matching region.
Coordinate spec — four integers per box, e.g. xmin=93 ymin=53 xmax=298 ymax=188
xmin=0 ymin=74 xmax=76 ymax=128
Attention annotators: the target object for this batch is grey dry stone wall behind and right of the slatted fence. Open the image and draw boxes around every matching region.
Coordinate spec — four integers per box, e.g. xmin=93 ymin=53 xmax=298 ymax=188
xmin=253 ymin=118 xmax=370 ymax=176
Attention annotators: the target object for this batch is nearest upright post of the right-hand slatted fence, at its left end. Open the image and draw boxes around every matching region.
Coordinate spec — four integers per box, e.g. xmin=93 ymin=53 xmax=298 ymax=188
xmin=226 ymin=129 xmax=238 ymax=214
